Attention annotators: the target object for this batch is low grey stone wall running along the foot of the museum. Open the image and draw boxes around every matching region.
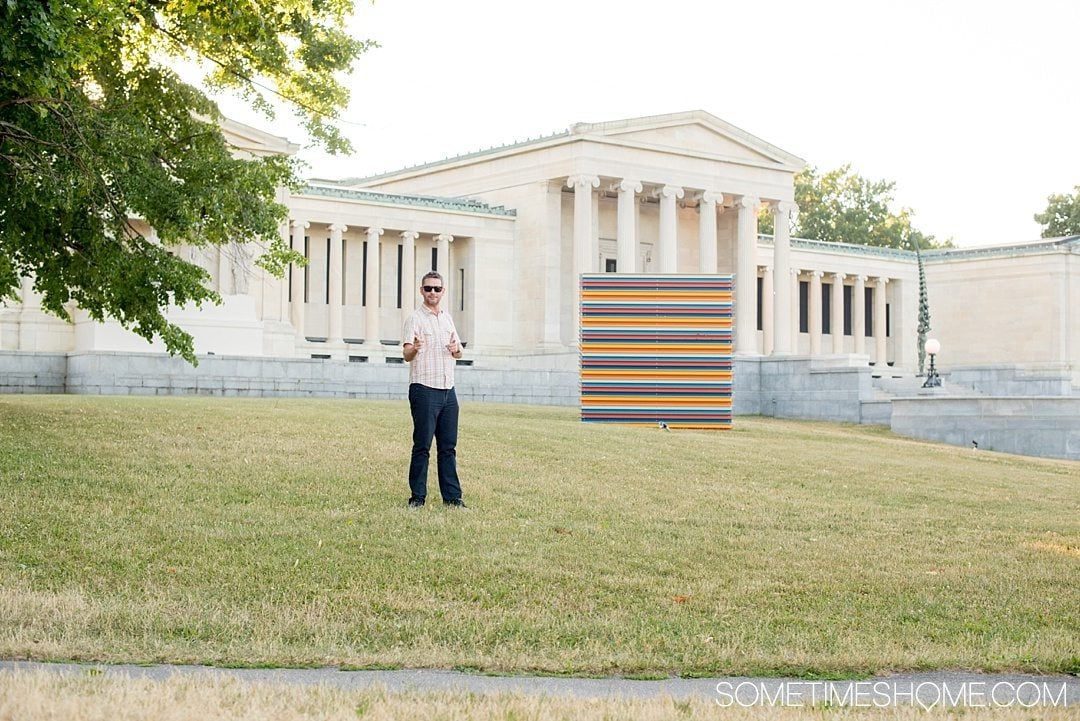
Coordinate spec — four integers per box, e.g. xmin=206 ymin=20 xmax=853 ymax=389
xmin=0 ymin=351 xmax=1080 ymax=460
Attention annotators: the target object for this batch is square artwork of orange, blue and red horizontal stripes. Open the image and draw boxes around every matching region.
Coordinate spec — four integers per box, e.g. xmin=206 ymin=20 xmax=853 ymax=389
xmin=581 ymin=273 xmax=733 ymax=428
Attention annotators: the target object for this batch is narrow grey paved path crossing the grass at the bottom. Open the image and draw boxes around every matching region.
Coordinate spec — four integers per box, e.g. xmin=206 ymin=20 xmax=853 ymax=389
xmin=0 ymin=661 xmax=1080 ymax=709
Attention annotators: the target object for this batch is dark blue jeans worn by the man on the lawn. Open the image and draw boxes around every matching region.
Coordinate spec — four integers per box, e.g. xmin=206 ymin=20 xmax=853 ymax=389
xmin=408 ymin=383 xmax=461 ymax=501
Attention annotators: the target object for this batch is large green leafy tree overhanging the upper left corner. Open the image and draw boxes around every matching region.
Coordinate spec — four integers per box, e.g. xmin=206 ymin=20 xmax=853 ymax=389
xmin=0 ymin=0 xmax=372 ymax=363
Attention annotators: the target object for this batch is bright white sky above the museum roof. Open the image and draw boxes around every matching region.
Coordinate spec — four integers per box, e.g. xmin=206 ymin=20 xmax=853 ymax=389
xmin=208 ymin=0 xmax=1080 ymax=246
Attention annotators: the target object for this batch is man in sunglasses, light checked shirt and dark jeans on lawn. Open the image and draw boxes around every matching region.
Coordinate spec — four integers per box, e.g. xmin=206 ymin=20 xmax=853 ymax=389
xmin=402 ymin=271 xmax=465 ymax=508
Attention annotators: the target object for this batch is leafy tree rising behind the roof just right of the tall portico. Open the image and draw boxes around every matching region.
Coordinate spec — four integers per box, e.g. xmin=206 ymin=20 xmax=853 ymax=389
xmin=758 ymin=165 xmax=951 ymax=248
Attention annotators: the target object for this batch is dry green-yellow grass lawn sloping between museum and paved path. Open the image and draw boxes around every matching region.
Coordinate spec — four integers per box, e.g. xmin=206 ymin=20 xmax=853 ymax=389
xmin=0 ymin=396 xmax=1080 ymax=678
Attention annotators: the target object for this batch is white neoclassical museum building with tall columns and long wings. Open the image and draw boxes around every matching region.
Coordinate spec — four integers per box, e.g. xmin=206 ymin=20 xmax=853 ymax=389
xmin=0 ymin=111 xmax=1080 ymax=440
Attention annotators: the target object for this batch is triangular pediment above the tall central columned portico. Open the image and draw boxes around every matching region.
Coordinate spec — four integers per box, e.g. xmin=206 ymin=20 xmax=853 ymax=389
xmin=570 ymin=110 xmax=806 ymax=172
